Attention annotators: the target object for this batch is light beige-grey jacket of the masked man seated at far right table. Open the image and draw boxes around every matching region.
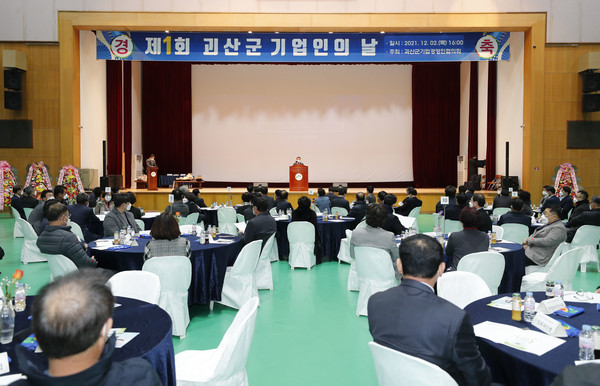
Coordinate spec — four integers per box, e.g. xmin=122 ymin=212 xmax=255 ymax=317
xmin=525 ymin=221 xmax=567 ymax=266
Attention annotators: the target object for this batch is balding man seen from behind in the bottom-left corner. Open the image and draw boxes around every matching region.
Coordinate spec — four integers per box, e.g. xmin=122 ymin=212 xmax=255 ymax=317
xmin=13 ymin=269 xmax=162 ymax=386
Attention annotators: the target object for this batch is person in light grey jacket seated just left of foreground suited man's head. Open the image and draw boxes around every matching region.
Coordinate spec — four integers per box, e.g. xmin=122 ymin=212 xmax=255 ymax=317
xmin=350 ymin=204 xmax=400 ymax=278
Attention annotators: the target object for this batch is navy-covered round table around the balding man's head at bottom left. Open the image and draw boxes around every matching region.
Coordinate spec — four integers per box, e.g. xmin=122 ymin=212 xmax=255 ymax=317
xmin=0 ymin=296 xmax=176 ymax=385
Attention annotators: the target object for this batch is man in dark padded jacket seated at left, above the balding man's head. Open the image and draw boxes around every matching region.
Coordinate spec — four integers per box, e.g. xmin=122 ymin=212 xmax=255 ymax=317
xmin=36 ymin=200 xmax=98 ymax=268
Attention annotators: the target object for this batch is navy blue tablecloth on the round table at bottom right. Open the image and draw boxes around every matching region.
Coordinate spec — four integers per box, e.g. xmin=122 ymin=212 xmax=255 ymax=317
xmin=465 ymin=292 xmax=600 ymax=386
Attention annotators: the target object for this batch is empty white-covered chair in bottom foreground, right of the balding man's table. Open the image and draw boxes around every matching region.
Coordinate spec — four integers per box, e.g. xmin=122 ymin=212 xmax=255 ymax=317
xmin=175 ymin=297 xmax=259 ymax=386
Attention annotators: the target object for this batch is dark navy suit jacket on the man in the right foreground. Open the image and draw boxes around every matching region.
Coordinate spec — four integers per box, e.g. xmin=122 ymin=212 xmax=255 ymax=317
xmin=368 ymin=279 xmax=491 ymax=386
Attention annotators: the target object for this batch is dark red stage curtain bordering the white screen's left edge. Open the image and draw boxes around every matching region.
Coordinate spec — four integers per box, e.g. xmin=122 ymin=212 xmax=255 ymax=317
xmin=142 ymin=62 xmax=191 ymax=174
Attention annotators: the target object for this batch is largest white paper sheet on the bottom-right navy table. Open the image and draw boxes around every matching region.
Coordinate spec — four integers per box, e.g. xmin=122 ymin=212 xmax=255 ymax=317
xmin=473 ymin=322 xmax=565 ymax=355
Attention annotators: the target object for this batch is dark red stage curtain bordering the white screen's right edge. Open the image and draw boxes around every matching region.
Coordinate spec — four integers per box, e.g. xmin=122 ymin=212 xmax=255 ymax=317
xmin=412 ymin=63 xmax=460 ymax=188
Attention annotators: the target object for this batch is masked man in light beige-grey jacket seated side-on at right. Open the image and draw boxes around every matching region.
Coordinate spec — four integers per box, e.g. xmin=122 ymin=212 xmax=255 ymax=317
xmin=523 ymin=206 xmax=567 ymax=267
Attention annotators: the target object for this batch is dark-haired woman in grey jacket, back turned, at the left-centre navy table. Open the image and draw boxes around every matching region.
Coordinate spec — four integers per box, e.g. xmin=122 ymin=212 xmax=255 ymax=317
xmin=144 ymin=212 xmax=190 ymax=261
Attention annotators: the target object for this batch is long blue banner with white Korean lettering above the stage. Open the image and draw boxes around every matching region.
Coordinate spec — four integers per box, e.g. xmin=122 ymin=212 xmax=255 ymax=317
xmin=96 ymin=31 xmax=510 ymax=63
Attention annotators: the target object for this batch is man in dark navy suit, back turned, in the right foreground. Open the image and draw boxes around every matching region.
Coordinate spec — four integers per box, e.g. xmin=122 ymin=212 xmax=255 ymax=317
xmin=368 ymin=235 xmax=491 ymax=386
